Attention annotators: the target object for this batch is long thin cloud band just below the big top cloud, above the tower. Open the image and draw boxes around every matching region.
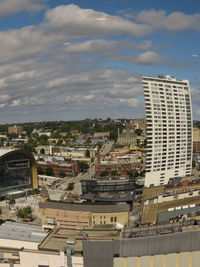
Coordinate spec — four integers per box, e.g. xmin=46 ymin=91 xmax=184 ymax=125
xmin=64 ymin=40 xmax=186 ymax=68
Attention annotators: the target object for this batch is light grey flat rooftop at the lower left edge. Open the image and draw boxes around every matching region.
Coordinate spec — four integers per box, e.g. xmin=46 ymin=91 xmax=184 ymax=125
xmin=0 ymin=221 xmax=47 ymax=243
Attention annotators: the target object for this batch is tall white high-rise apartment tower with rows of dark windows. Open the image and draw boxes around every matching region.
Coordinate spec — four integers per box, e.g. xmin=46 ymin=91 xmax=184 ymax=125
xmin=143 ymin=75 xmax=192 ymax=187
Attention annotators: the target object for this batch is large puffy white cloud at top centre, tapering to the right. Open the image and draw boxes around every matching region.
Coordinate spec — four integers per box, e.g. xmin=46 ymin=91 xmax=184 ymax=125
xmin=46 ymin=5 xmax=151 ymax=37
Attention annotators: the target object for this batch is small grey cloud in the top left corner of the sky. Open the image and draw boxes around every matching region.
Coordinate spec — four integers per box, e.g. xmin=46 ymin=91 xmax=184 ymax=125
xmin=0 ymin=0 xmax=45 ymax=16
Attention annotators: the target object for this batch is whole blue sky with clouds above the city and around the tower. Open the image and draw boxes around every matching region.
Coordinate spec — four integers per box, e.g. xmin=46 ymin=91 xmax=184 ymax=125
xmin=0 ymin=0 xmax=200 ymax=124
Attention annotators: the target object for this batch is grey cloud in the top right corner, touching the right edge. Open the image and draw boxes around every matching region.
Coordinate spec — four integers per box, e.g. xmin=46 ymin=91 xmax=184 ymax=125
xmin=136 ymin=9 xmax=200 ymax=31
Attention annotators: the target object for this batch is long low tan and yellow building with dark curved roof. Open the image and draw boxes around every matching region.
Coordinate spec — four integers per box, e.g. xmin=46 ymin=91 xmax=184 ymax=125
xmin=39 ymin=200 xmax=130 ymax=227
